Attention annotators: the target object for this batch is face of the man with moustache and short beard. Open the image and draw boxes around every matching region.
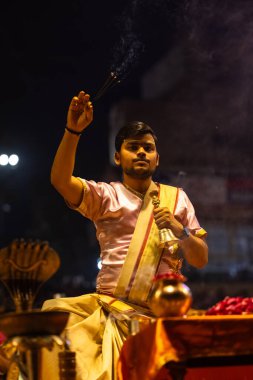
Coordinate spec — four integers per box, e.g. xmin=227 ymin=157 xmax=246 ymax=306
xmin=115 ymin=133 xmax=159 ymax=179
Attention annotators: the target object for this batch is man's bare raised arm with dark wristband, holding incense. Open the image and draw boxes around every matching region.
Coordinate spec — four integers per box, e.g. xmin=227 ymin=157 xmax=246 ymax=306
xmin=51 ymin=91 xmax=93 ymax=206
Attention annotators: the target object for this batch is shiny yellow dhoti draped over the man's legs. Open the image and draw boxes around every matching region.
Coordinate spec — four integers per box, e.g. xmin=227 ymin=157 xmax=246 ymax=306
xmin=42 ymin=294 xmax=128 ymax=380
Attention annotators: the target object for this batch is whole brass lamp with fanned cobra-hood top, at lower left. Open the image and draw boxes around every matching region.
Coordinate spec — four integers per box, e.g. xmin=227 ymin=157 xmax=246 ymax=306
xmin=0 ymin=239 xmax=74 ymax=380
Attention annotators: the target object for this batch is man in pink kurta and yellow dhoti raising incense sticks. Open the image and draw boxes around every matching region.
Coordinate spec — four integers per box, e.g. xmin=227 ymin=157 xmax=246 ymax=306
xmin=43 ymin=91 xmax=208 ymax=380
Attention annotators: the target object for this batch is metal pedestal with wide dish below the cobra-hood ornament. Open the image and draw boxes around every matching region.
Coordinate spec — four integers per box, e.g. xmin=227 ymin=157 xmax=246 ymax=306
xmin=0 ymin=311 xmax=69 ymax=380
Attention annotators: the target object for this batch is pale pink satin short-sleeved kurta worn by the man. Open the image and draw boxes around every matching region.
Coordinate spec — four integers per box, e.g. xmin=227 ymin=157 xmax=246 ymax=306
xmin=71 ymin=179 xmax=205 ymax=294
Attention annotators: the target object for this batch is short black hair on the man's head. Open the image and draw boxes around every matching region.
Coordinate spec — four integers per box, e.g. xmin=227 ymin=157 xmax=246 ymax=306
xmin=115 ymin=121 xmax=157 ymax=152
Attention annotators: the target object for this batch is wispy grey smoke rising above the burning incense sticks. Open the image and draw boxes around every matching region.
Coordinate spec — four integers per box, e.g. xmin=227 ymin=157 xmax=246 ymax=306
xmin=111 ymin=0 xmax=180 ymax=79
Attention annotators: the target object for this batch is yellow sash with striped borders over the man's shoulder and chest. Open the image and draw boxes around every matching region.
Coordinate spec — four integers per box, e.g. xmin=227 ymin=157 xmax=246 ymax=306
xmin=114 ymin=182 xmax=178 ymax=306
